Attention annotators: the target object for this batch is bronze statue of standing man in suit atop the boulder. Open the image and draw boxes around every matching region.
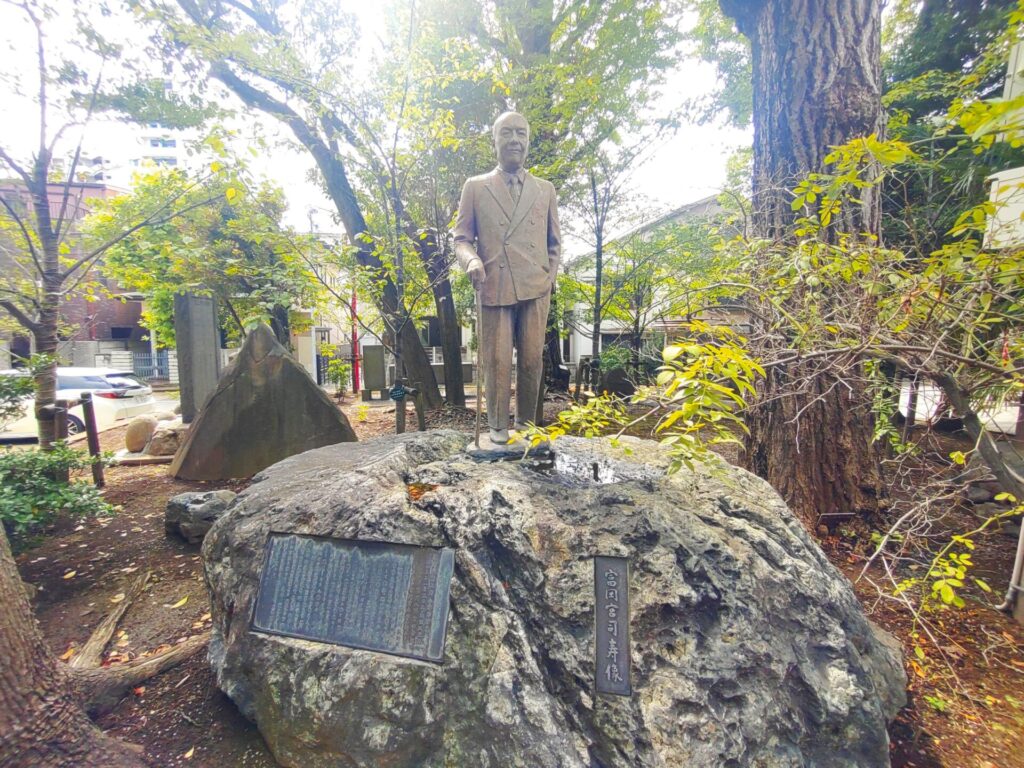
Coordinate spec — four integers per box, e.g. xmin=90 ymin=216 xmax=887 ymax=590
xmin=455 ymin=112 xmax=561 ymax=444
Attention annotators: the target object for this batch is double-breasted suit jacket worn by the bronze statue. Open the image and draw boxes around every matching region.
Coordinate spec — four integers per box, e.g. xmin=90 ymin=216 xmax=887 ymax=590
xmin=455 ymin=168 xmax=561 ymax=306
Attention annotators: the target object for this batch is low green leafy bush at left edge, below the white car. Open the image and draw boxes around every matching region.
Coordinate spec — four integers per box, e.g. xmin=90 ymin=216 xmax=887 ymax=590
xmin=0 ymin=442 xmax=114 ymax=536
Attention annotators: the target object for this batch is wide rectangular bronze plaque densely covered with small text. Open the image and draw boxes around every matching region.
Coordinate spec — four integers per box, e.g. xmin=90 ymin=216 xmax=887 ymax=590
xmin=252 ymin=532 xmax=455 ymax=662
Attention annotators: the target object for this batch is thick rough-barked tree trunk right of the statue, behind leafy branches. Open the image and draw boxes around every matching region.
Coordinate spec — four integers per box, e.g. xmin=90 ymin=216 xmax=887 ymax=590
xmin=720 ymin=0 xmax=882 ymax=525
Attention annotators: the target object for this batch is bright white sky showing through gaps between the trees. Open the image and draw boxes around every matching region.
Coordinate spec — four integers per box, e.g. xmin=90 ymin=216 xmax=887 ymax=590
xmin=0 ymin=0 xmax=751 ymax=257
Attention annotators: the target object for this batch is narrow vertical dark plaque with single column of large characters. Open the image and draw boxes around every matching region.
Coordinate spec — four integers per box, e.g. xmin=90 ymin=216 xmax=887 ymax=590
xmin=594 ymin=555 xmax=633 ymax=696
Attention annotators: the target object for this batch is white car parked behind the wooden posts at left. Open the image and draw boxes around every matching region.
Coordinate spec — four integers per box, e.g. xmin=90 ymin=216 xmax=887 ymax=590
xmin=0 ymin=368 xmax=157 ymax=435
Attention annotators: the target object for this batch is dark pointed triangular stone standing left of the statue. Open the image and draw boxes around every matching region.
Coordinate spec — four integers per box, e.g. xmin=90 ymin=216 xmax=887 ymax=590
xmin=171 ymin=325 xmax=356 ymax=480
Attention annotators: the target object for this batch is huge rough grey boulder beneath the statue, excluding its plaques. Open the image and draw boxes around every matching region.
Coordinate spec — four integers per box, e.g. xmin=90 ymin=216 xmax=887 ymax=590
xmin=203 ymin=431 xmax=905 ymax=768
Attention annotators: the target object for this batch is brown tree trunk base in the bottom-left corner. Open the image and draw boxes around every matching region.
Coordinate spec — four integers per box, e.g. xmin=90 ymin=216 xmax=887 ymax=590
xmin=0 ymin=526 xmax=143 ymax=768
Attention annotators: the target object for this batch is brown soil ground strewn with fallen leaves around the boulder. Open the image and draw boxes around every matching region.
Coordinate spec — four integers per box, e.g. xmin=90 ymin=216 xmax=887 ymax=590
xmin=9 ymin=401 xmax=1024 ymax=768
